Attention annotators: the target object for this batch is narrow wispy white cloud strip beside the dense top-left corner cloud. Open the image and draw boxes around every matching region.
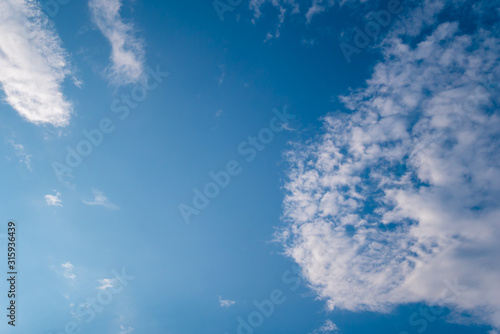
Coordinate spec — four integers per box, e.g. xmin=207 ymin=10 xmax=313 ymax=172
xmin=89 ymin=0 xmax=145 ymax=85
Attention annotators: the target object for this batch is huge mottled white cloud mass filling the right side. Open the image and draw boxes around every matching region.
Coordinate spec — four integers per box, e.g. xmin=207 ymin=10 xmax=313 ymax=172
xmin=279 ymin=1 xmax=500 ymax=328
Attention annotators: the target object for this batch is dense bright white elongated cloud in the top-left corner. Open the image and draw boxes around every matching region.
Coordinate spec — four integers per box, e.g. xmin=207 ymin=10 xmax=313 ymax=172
xmin=0 ymin=0 xmax=73 ymax=126
